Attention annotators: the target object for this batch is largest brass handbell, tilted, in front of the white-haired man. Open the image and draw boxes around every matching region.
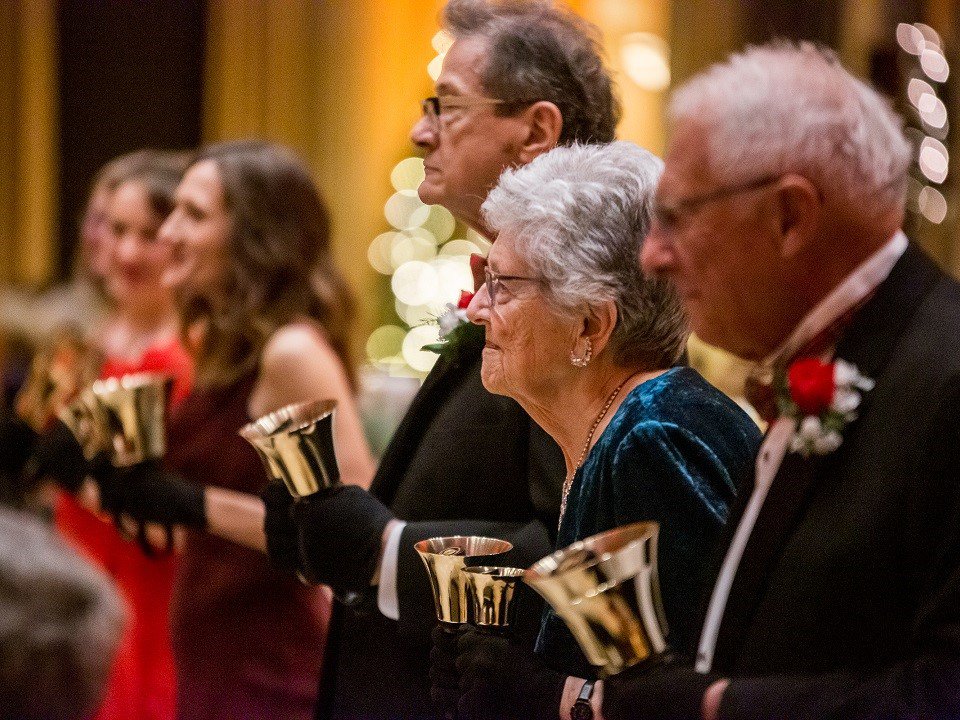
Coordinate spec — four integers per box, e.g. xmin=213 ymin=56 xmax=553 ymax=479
xmin=524 ymin=522 xmax=667 ymax=677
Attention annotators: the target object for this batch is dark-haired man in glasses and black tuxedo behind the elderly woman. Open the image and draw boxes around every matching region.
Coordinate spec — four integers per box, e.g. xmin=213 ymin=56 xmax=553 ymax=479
xmin=267 ymin=0 xmax=619 ymax=720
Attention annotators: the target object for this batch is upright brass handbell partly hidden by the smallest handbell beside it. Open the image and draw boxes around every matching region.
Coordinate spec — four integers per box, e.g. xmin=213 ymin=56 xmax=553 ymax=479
xmin=413 ymin=535 xmax=513 ymax=626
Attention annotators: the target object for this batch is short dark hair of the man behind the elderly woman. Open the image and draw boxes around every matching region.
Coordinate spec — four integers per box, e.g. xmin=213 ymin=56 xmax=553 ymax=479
xmin=443 ymin=0 xmax=620 ymax=145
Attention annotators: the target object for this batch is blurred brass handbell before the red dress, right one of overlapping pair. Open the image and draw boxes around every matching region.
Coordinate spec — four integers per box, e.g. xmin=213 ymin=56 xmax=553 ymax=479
xmin=90 ymin=373 xmax=173 ymax=467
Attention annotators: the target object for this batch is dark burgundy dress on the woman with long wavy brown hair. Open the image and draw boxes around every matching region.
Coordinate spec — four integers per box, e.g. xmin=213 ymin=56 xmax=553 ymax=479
xmin=167 ymin=375 xmax=330 ymax=720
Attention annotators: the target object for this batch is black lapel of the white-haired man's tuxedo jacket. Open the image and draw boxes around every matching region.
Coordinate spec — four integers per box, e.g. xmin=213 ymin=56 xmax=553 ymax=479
xmin=714 ymin=244 xmax=943 ymax=670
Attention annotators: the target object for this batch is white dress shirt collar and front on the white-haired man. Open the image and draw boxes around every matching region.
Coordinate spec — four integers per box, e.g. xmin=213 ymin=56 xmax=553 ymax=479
xmin=695 ymin=231 xmax=907 ymax=673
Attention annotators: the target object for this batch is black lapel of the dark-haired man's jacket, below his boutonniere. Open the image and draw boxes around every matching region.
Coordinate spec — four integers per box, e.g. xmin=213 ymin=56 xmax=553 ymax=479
xmin=370 ymin=343 xmax=483 ymax=505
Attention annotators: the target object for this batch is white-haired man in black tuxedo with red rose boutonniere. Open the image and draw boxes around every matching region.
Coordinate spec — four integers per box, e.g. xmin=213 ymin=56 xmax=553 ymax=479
xmin=603 ymin=43 xmax=960 ymax=720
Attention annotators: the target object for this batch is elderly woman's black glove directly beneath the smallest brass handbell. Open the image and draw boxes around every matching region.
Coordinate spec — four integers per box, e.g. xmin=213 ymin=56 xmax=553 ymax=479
xmin=457 ymin=629 xmax=567 ymax=720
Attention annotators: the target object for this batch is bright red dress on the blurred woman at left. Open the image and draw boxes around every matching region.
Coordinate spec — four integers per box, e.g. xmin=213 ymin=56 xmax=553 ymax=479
xmin=55 ymin=339 xmax=192 ymax=720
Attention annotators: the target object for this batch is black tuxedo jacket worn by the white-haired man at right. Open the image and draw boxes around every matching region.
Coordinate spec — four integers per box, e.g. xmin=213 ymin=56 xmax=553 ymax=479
xmin=700 ymin=246 xmax=960 ymax=720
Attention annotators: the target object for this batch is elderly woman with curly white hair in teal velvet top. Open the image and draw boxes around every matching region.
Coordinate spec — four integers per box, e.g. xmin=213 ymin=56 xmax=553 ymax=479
xmin=433 ymin=142 xmax=760 ymax=720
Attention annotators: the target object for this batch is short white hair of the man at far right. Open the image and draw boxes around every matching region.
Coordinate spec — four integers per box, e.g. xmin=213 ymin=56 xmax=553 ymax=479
xmin=668 ymin=41 xmax=912 ymax=213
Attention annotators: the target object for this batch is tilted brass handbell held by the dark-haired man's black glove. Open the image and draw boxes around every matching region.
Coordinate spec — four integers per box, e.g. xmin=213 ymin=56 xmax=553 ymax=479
xmin=240 ymin=400 xmax=340 ymax=498
